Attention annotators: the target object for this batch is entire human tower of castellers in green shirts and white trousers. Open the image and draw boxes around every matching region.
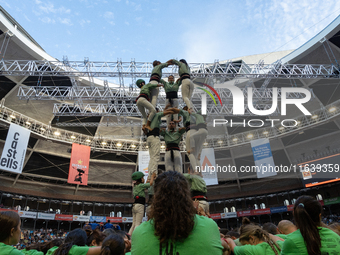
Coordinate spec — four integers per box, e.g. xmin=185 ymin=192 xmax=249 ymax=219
xmin=129 ymin=59 xmax=209 ymax=234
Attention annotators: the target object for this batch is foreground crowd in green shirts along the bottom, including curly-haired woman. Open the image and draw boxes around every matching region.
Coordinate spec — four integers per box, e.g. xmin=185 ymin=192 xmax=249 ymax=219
xmin=0 ymin=171 xmax=340 ymax=255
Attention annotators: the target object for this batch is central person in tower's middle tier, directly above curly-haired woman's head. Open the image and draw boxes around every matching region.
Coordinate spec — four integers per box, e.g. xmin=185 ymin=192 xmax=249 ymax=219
xmin=161 ymin=121 xmax=185 ymax=173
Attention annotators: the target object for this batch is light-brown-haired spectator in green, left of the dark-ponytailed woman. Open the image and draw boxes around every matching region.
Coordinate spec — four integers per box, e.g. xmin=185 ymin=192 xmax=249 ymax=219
xmin=226 ymin=218 xmax=283 ymax=255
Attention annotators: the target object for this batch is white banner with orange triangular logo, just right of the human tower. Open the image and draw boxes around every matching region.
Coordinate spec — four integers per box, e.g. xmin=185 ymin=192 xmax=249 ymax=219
xmin=200 ymin=148 xmax=218 ymax=186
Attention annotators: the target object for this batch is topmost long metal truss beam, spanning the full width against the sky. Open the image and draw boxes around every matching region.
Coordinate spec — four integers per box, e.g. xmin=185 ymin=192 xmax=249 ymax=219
xmin=0 ymin=59 xmax=340 ymax=79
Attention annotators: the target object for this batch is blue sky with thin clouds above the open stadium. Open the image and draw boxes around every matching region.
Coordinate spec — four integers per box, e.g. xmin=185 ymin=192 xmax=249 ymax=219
xmin=0 ymin=0 xmax=340 ymax=63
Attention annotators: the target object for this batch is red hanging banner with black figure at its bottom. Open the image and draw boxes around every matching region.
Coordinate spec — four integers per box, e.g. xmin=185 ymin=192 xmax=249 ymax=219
xmin=67 ymin=143 xmax=91 ymax=185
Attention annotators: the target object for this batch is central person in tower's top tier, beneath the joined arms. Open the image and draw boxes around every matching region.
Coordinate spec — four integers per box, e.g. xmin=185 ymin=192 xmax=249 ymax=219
xmin=160 ymin=75 xmax=181 ymax=126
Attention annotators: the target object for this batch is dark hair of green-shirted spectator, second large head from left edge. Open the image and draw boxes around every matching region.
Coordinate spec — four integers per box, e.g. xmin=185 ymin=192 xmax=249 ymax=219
xmin=53 ymin=228 xmax=87 ymax=255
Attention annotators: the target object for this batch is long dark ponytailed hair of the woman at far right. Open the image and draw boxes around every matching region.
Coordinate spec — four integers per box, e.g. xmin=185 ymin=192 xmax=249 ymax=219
xmin=293 ymin=196 xmax=322 ymax=255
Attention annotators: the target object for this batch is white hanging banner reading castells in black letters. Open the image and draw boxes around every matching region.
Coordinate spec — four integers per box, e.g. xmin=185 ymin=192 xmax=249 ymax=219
xmin=0 ymin=123 xmax=31 ymax=174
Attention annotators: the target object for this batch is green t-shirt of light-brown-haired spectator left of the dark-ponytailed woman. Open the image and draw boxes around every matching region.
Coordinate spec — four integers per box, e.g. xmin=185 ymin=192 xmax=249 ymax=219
xmin=234 ymin=241 xmax=283 ymax=255
